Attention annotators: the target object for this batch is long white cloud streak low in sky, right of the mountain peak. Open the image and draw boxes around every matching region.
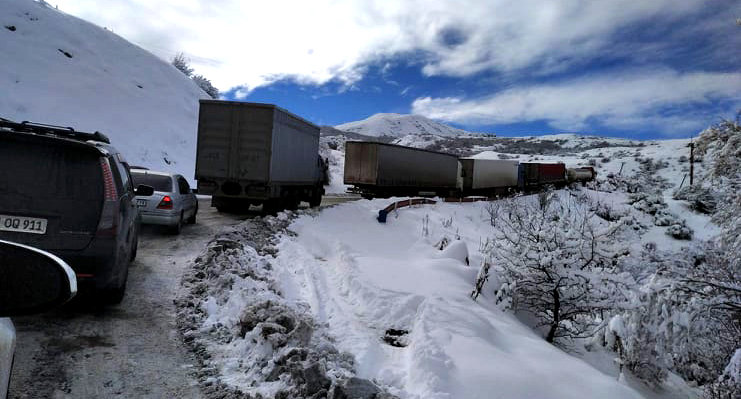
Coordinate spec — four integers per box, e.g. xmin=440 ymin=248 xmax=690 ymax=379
xmin=412 ymin=69 xmax=741 ymax=134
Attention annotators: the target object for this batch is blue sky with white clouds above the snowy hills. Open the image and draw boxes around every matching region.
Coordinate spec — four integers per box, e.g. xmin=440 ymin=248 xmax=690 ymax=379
xmin=52 ymin=0 xmax=741 ymax=138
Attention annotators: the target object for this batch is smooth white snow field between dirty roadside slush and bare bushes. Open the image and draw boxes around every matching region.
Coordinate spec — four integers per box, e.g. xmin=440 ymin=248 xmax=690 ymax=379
xmin=276 ymin=200 xmax=641 ymax=398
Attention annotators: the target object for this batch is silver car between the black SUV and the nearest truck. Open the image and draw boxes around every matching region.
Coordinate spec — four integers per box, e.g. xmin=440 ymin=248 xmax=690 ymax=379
xmin=131 ymin=169 xmax=198 ymax=234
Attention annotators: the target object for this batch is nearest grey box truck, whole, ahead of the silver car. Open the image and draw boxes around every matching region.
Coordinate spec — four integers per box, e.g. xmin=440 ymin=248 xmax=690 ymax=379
xmin=195 ymin=100 xmax=329 ymax=214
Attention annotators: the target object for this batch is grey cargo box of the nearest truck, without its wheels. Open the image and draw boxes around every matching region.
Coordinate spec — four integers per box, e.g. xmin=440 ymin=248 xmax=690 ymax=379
xmin=196 ymin=100 xmax=319 ymax=185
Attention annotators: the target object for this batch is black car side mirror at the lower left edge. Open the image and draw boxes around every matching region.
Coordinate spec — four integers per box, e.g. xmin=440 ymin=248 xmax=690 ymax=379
xmin=0 ymin=240 xmax=77 ymax=317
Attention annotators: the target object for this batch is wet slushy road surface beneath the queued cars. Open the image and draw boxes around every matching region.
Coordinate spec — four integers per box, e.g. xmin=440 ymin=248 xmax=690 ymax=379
xmin=10 ymin=197 xmax=351 ymax=398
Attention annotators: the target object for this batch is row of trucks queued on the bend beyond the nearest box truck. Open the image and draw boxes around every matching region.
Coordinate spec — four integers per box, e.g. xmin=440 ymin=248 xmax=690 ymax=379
xmin=344 ymin=141 xmax=595 ymax=198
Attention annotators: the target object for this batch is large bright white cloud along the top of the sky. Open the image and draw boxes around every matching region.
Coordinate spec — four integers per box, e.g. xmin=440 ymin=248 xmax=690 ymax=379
xmin=55 ymin=0 xmax=705 ymax=91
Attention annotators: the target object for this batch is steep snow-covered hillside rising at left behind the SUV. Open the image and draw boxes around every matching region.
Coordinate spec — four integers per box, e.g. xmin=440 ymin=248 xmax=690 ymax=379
xmin=0 ymin=0 xmax=208 ymax=179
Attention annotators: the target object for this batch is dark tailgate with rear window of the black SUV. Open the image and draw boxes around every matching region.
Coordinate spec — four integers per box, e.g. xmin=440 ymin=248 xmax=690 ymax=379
xmin=0 ymin=132 xmax=104 ymax=249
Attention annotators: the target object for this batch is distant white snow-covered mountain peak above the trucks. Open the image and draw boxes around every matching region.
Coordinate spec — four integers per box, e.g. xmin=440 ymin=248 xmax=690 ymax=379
xmin=335 ymin=114 xmax=476 ymax=137
